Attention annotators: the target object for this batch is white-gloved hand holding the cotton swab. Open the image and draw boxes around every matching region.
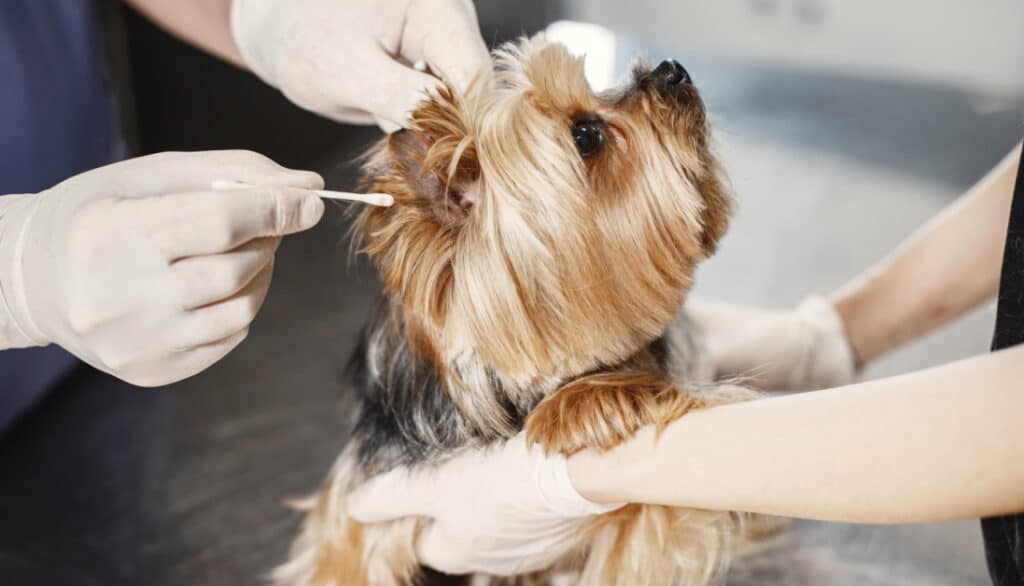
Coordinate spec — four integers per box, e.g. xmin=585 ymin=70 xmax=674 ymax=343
xmin=0 ymin=151 xmax=324 ymax=386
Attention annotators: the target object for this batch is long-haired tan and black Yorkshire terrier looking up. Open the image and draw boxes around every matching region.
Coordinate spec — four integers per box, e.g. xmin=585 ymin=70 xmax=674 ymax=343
xmin=274 ymin=37 xmax=765 ymax=586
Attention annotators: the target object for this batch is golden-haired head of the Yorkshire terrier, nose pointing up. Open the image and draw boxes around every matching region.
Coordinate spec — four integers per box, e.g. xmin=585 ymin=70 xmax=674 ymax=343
xmin=357 ymin=37 xmax=730 ymax=383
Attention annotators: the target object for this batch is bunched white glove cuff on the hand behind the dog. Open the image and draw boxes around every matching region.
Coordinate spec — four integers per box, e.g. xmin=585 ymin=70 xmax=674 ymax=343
xmin=797 ymin=295 xmax=857 ymax=388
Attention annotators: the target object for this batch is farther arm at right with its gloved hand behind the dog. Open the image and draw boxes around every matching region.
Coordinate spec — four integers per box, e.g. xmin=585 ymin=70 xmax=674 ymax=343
xmin=687 ymin=145 xmax=1020 ymax=390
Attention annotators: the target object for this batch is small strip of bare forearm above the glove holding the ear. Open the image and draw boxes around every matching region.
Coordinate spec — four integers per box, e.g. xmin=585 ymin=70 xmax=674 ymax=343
xmin=125 ymin=0 xmax=246 ymax=68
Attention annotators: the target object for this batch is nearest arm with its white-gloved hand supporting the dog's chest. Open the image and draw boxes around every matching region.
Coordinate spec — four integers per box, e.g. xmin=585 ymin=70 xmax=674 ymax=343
xmin=348 ymin=346 xmax=1024 ymax=574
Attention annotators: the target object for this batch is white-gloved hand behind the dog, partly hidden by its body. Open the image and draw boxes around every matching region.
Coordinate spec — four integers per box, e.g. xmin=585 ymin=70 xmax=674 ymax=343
xmin=686 ymin=297 xmax=856 ymax=390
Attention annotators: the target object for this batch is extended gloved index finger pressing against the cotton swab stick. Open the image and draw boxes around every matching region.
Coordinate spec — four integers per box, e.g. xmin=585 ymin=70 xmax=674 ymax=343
xmin=140 ymin=184 xmax=324 ymax=261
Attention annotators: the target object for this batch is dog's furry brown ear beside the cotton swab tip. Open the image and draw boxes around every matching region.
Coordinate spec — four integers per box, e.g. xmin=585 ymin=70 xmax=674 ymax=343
xmin=353 ymin=94 xmax=481 ymax=327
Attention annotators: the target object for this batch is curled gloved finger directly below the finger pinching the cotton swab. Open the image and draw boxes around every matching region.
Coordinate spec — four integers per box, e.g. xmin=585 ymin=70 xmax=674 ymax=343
xmin=171 ymin=237 xmax=281 ymax=309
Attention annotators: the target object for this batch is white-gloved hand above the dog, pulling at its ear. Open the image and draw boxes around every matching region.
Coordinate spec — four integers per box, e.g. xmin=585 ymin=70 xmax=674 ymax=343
xmin=231 ymin=0 xmax=490 ymax=131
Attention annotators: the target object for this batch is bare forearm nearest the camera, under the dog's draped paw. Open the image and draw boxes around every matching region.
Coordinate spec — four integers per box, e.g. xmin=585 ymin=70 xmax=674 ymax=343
xmin=569 ymin=347 xmax=1024 ymax=522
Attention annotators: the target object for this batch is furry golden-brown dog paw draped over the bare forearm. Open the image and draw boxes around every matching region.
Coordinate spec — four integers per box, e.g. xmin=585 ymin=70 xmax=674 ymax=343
xmin=525 ymin=370 xmax=695 ymax=455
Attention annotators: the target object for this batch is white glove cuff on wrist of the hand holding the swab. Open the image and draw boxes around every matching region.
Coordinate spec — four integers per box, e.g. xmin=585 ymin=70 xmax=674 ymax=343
xmin=0 ymin=195 xmax=49 ymax=348
